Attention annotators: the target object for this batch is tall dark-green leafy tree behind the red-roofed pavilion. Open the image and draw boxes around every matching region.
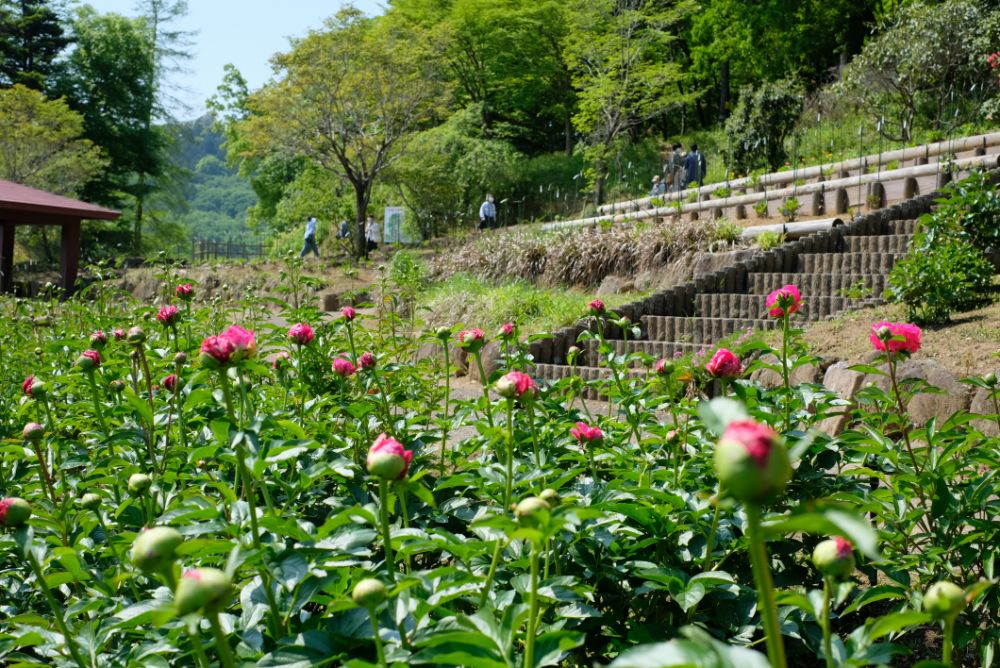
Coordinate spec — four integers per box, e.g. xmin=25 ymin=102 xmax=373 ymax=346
xmin=62 ymin=6 xmax=167 ymax=253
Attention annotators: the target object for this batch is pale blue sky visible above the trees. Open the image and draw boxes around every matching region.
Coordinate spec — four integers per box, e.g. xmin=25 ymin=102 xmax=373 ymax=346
xmin=81 ymin=0 xmax=383 ymax=119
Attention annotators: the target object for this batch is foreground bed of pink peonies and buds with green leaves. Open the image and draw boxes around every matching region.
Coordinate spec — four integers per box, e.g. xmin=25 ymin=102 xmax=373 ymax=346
xmin=0 ymin=272 xmax=1000 ymax=668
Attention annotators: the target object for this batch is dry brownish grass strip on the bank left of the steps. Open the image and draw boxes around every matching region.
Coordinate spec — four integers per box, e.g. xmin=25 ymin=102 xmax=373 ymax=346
xmin=432 ymin=220 xmax=736 ymax=286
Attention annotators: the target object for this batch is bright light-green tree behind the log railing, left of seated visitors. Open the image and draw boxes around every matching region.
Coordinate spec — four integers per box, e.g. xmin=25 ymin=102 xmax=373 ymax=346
xmin=566 ymin=0 xmax=692 ymax=204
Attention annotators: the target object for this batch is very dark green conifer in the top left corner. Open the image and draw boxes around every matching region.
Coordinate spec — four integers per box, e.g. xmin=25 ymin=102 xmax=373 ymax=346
xmin=0 ymin=0 xmax=70 ymax=90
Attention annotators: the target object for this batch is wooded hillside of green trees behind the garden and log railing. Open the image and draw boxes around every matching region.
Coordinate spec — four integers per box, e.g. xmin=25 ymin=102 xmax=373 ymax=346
xmin=0 ymin=0 xmax=1000 ymax=257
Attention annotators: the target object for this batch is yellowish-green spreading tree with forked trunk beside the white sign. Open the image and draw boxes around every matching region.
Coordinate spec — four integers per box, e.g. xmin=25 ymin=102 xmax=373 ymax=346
xmin=239 ymin=8 xmax=441 ymax=256
